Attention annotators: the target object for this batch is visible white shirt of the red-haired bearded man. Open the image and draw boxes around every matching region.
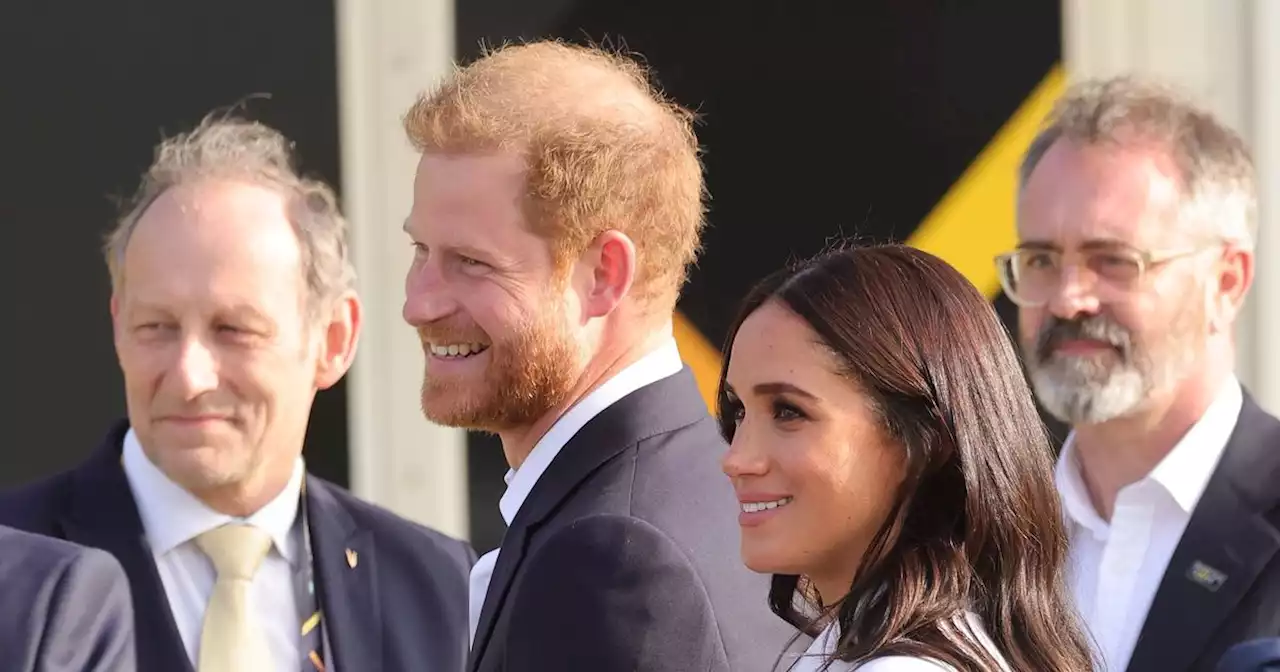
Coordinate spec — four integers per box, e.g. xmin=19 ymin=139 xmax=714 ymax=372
xmin=470 ymin=338 xmax=685 ymax=641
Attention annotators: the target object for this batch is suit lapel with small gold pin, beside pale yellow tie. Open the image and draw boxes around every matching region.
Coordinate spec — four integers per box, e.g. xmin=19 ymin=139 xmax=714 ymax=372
xmin=306 ymin=475 xmax=383 ymax=672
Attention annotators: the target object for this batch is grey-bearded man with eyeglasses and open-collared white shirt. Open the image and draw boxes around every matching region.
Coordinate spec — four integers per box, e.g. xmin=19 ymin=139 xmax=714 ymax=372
xmin=997 ymin=78 xmax=1280 ymax=672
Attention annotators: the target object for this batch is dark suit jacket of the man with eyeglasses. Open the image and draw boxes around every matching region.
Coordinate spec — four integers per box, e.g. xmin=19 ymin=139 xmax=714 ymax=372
xmin=1128 ymin=393 xmax=1280 ymax=672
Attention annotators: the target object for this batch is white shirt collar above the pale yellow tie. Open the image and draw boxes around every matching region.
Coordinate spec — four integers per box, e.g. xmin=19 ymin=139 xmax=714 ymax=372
xmin=123 ymin=428 xmax=306 ymax=563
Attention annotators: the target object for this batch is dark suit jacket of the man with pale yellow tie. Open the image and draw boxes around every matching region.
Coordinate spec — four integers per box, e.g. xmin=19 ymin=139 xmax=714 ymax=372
xmin=0 ymin=422 xmax=475 ymax=672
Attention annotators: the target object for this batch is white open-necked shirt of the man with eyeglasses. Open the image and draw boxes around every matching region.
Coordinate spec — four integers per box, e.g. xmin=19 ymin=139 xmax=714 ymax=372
xmin=1055 ymin=378 xmax=1244 ymax=669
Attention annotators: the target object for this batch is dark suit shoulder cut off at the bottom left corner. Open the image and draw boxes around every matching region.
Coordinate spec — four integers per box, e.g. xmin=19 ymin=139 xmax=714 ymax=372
xmin=0 ymin=527 xmax=137 ymax=672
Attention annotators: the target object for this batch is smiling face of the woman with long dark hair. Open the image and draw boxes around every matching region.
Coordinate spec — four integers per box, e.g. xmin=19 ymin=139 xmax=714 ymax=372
xmin=723 ymin=301 xmax=905 ymax=603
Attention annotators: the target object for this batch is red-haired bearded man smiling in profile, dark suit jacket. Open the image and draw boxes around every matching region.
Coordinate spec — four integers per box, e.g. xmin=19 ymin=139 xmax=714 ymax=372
xmin=404 ymin=42 xmax=791 ymax=672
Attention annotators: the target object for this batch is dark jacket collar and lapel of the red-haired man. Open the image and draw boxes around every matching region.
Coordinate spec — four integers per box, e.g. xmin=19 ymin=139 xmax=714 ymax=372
xmin=468 ymin=367 xmax=707 ymax=672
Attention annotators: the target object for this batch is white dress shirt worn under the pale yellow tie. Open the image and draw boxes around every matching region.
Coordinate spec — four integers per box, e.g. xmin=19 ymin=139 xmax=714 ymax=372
xmin=124 ymin=429 xmax=305 ymax=672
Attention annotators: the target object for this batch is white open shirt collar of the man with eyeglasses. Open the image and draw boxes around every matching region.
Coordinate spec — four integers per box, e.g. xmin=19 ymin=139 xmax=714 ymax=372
xmin=1055 ymin=376 xmax=1244 ymax=532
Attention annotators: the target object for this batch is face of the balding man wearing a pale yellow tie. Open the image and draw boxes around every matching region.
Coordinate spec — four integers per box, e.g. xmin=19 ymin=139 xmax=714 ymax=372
xmin=111 ymin=182 xmax=355 ymax=507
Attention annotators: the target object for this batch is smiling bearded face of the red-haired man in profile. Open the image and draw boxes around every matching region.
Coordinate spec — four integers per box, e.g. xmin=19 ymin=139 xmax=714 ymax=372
xmin=404 ymin=154 xmax=585 ymax=431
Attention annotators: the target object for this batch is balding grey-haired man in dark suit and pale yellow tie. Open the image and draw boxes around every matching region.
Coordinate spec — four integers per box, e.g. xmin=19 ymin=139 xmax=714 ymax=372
xmin=0 ymin=113 xmax=475 ymax=672
